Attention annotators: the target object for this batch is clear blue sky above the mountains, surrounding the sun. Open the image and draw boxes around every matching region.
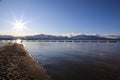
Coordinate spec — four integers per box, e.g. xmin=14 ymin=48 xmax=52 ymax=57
xmin=0 ymin=0 xmax=120 ymax=35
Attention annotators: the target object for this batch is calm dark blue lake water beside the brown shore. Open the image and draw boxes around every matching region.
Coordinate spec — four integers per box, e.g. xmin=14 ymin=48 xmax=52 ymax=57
xmin=23 ymin=42 xmax=120 ymax=80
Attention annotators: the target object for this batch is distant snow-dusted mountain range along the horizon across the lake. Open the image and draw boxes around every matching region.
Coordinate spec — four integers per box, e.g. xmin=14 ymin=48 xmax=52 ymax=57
xmin=0 ymin=34 xmax=120 ymax=40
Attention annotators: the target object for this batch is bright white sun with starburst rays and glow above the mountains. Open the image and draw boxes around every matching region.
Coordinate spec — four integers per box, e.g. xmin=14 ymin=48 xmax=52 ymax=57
xmin=8 ymin=16 xmax=35 ymax=36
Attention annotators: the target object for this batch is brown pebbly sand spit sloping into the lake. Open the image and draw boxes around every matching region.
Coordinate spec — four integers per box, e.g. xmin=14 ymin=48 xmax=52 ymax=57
xmin=0 ymin=43 xmax=48 ymax=80
